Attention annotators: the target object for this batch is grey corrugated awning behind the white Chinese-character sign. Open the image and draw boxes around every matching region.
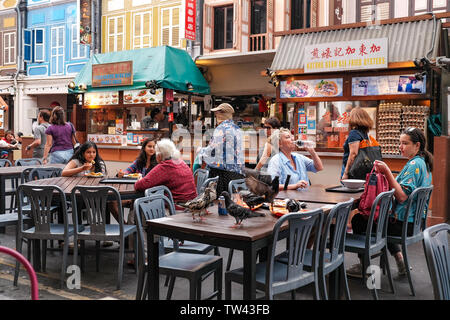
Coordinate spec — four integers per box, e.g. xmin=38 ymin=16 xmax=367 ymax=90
xmin=270 ymin=20 xmax=441 ymax=71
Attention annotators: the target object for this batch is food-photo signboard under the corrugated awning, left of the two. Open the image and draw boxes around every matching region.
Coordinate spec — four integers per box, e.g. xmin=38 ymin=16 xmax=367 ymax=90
xmin=280 ymin=78 xmax=343 ymax=99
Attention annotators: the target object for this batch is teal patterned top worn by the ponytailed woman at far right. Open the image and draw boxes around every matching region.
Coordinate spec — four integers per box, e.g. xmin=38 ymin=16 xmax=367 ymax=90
xmin=392 ymin=156 xmax=432 ymax=222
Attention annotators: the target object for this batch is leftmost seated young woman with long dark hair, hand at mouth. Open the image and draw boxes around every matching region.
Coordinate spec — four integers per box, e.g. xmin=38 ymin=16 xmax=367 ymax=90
xmin=61 ymin=141 xmax=106 ymax=177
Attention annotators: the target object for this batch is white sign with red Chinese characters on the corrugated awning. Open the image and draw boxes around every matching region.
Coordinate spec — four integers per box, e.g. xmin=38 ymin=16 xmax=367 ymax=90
xmin=304 ymin=38 xmax=388 ymax=73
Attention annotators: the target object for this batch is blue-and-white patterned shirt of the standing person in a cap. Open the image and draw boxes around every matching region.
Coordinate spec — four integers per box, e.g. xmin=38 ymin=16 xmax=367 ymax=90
xmin=199 ymin=120 xmax=245 ymax=174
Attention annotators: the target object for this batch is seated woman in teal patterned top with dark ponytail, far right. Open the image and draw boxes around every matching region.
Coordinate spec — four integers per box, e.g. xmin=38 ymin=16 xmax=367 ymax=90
xmin=347 ymin=128 xmax=433 ymax=277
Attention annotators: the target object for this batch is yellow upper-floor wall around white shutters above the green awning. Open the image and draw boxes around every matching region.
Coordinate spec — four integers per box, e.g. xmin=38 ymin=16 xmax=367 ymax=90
xmin=101 ymin=0 xmax=186 ymax=53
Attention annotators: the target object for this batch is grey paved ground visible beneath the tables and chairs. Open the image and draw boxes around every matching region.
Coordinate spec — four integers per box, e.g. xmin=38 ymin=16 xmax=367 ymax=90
xmin=0 ymin=218 xmax=440 ymax=300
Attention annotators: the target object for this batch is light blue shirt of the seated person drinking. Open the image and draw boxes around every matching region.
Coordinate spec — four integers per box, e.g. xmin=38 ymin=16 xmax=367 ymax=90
xmin=267 ymin=152 xmax=317 ymax=189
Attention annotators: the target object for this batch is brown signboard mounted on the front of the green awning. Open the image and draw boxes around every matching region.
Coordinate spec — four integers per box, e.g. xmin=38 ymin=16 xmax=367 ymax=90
xmin=92 ymin=61 xmax=133 ymax=87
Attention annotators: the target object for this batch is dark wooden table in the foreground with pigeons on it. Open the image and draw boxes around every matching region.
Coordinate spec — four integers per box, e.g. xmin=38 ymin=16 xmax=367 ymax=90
xmin=146 ymin=202 xmax=333 ymax=300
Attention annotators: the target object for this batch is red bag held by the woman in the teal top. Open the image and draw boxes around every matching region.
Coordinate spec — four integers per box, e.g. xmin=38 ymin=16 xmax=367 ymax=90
xmin=358 ymin=167 xmax=389 ymax=221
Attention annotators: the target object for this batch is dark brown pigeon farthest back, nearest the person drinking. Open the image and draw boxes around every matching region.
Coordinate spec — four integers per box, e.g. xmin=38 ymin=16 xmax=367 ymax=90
xmin=244 ymin=169 xmax=280 ymax=207
